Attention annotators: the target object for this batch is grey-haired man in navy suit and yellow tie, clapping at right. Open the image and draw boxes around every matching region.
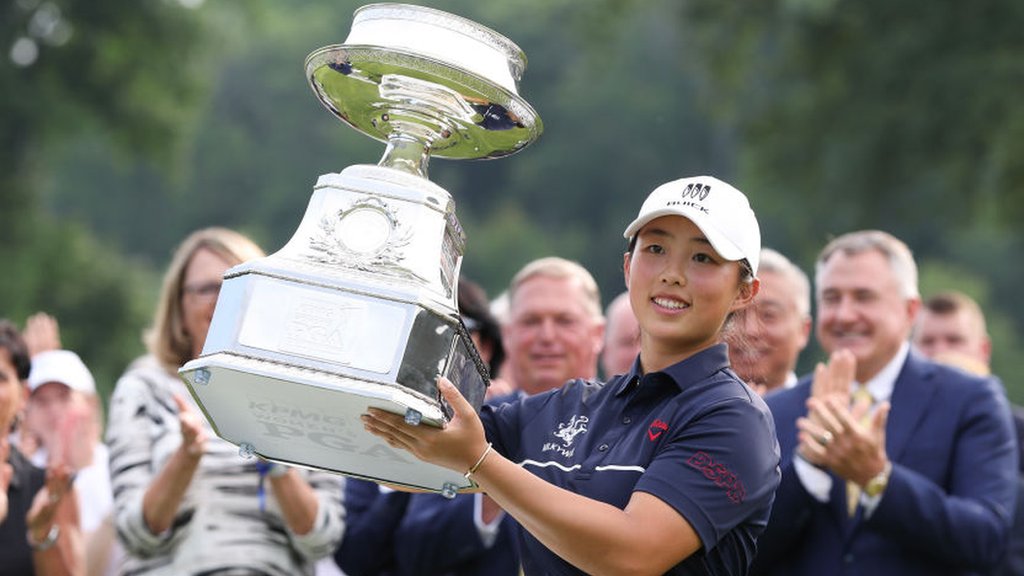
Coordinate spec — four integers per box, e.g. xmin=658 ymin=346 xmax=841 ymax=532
xmin=752 ymin=231 xmax=1018 ymax=576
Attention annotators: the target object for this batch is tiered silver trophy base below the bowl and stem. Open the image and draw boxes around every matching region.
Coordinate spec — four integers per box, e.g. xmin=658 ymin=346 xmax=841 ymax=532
xmin=179 ymin=166 xmax=487 ymax=495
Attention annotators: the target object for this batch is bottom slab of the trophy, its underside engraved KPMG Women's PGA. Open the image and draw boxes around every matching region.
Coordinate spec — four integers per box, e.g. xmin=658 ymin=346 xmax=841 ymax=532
xmin=181 ymin=354 xmax=475 ymax=496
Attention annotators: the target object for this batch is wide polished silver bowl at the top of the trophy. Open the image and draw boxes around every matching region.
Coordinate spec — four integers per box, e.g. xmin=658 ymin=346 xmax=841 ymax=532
xmin=306 ymin=4 xmax=543 ymax=163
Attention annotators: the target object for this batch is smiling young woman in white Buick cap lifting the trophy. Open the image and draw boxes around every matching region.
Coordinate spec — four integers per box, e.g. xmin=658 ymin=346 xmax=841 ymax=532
xmin=364 ymin=176 xmax=779 ymax=575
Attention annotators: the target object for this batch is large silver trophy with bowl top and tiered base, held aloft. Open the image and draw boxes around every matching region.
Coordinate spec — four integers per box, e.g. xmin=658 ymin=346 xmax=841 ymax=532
xmin=180 ymin=4 xmax=543 ymax=496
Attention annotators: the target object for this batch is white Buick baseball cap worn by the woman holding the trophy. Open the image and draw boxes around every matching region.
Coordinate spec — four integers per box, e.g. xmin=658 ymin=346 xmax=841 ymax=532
xmin=623 ymin=176 xmax=761 ymax=276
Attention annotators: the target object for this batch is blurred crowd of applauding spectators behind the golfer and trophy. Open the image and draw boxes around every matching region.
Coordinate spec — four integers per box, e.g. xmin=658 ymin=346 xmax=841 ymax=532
xmin=0 ymin=218 xmax=1024 ymax=576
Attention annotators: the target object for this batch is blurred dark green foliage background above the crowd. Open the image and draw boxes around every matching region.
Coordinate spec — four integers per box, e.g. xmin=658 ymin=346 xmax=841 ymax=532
xmin=0 ymin=0 xmax=1024 ymax=402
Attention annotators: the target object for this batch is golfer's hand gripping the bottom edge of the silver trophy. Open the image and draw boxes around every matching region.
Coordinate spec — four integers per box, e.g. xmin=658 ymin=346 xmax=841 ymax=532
xmin=361 ymin=377 xmax=487 ymax=474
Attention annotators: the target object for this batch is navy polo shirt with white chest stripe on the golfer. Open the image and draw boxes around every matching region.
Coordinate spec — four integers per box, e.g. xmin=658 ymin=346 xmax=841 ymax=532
xmin=480 ymin=344 xmax=780 ymax=575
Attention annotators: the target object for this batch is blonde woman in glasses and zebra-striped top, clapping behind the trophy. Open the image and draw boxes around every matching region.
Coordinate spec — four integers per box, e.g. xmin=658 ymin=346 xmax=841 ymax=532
xmin=108 ymin=229 xmax=342 ymax=576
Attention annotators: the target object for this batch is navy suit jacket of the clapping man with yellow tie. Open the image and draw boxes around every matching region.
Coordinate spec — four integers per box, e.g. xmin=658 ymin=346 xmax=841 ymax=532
xmin=751 ymin=351 xmax=1018 ymax=576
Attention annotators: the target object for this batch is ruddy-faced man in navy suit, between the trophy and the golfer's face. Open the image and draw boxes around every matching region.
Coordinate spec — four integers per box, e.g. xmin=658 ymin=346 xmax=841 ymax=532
xmin=335 ymin=257 xmax=605 ymax=576
